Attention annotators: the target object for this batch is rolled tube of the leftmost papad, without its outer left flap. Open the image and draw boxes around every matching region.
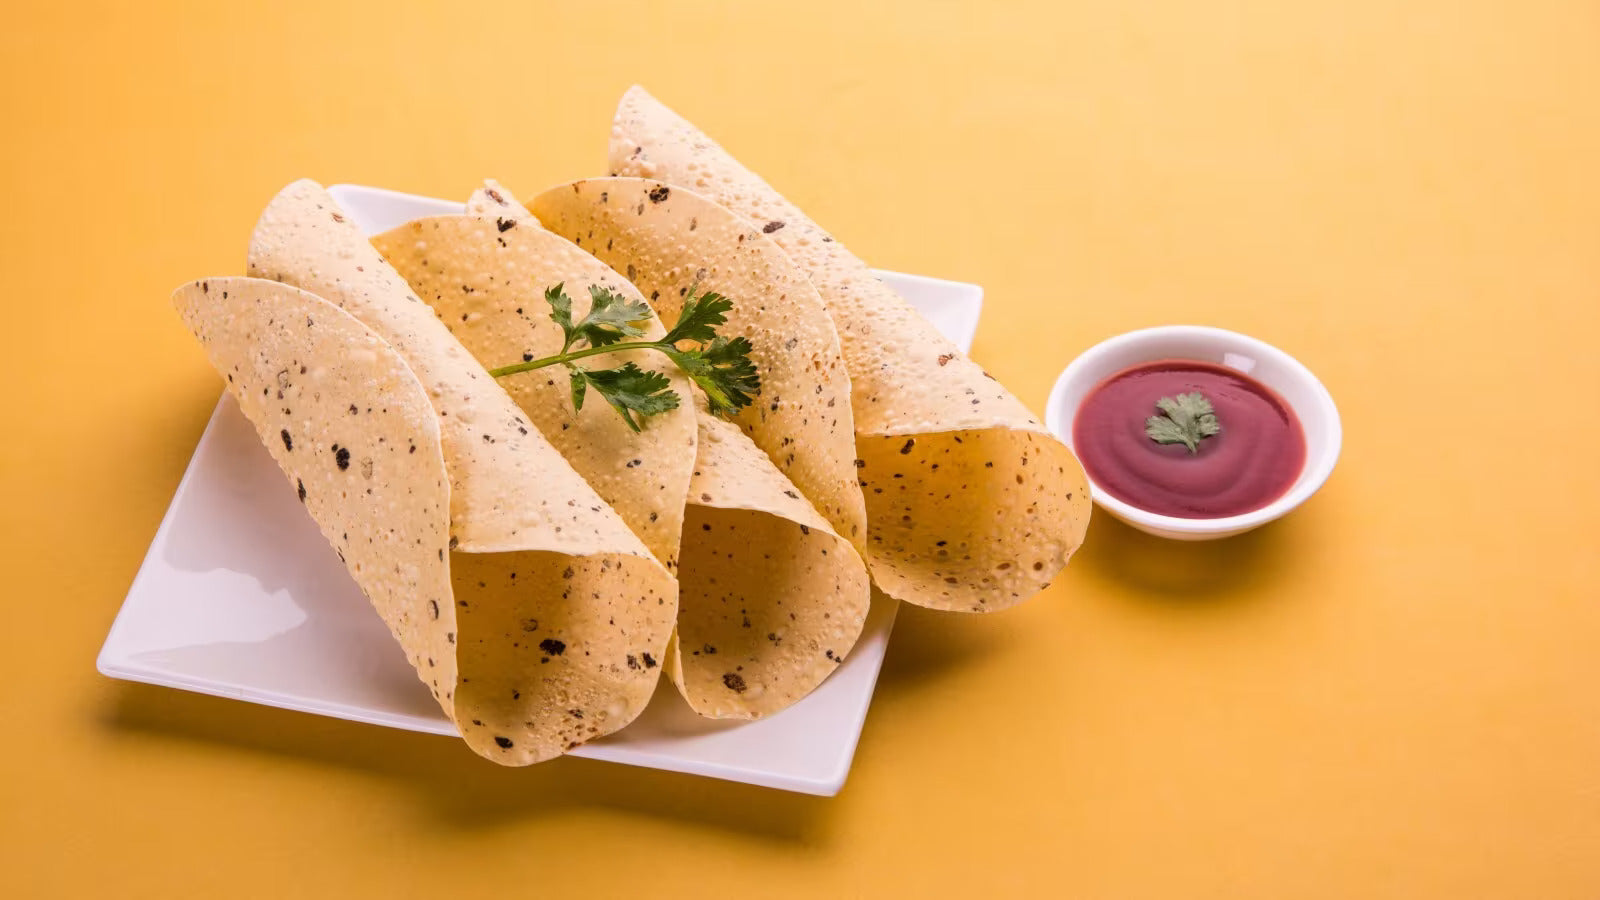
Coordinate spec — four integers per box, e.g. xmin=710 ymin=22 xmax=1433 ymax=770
xmin=250 ymin=181 xmax=677 ymax=764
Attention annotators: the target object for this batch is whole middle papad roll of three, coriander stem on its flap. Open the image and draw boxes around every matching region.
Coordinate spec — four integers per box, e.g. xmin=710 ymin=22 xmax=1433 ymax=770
xmin=373 ymin=184 xmax=869 ymax=719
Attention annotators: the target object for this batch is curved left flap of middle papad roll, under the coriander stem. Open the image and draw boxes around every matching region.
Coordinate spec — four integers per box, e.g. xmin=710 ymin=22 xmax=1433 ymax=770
xmin=373 ymin=211 xmax=694 ymax=569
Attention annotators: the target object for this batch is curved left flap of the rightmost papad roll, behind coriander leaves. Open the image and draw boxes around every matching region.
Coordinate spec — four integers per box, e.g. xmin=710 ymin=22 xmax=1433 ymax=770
xmin=531 ymin=178 xmax=867 ymax=549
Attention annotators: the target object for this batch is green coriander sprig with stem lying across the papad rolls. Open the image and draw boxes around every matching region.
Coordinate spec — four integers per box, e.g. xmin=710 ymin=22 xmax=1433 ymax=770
xmin=490 ymin=283 xmax=762 ymax=431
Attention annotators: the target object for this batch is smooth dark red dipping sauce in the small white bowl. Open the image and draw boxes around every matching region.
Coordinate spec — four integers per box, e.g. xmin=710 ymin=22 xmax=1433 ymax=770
xmin=1072 ymin=359 xmax=1306 ymax=519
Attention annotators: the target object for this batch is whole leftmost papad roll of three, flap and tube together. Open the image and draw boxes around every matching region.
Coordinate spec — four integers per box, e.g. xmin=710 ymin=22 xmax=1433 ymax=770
xmin=235 ymin=181 xmax=677 ymax=764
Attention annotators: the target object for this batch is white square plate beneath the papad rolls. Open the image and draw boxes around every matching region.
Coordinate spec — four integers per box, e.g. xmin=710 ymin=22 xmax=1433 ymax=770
xmin=99 ymin=186 xmax=982 ymax=796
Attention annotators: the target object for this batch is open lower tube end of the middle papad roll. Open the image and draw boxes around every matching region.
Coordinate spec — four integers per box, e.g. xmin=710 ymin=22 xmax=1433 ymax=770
xmin=667 ymin=408 xmax=870 ymax=719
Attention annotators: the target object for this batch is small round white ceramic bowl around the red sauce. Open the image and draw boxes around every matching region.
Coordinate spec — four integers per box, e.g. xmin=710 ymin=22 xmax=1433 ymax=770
xmin=1045 ymin=325 xmax=1344 ymax=541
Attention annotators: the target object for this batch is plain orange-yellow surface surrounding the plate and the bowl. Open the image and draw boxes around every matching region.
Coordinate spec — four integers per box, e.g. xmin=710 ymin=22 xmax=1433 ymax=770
xmin=0 ymin=0 xmax=1600 ymax=898
